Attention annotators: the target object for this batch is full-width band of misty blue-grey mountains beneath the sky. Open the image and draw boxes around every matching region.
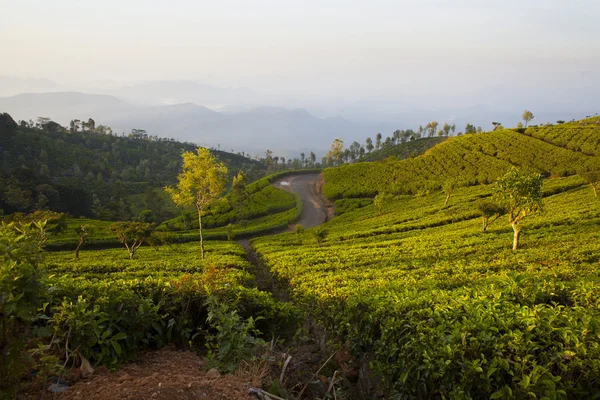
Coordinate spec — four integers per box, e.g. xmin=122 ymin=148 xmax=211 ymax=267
xmin=0 ymin=76 xmax=600 ymax=156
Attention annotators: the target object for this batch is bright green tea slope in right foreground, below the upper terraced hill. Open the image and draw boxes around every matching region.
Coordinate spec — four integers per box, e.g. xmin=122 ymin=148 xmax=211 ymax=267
xmin=253 ymin=176 xmax=600 ymax=398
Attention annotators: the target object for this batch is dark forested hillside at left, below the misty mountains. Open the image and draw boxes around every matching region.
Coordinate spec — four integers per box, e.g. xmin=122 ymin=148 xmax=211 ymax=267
xmin=0 ymin=114 xmax=263 ymax=219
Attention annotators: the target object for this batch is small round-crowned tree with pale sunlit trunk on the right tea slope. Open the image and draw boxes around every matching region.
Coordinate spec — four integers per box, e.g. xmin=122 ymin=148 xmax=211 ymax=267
xmin=494 ymin=167 xmax=544 ymax=251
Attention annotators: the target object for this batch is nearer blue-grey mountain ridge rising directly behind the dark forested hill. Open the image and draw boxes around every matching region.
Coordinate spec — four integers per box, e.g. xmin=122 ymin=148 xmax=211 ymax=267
xmin=0 ymin=92 xmax=394 ymax=156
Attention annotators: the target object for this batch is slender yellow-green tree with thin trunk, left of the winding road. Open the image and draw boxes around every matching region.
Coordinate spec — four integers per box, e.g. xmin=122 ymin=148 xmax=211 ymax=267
xmin=165 ymin=147 xmax=227 ymax=259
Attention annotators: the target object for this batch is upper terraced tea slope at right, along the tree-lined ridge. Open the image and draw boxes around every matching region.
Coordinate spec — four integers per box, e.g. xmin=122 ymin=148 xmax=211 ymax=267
xmin=323 ymin=120 xmax=600 ymax=199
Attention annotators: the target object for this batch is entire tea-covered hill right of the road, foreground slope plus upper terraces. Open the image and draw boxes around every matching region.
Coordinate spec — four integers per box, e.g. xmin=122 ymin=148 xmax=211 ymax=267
xmin=251 ymin=118 xmax=600 ymax=398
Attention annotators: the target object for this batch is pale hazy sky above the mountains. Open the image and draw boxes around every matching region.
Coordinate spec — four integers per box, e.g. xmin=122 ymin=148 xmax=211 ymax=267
xmin=0 ymin=0 xmax=600 ymax=98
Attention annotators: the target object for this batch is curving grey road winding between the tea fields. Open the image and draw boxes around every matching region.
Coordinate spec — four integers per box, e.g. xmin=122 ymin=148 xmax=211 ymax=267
xmin=273 ymin=174 xmax=327 ymax=228
